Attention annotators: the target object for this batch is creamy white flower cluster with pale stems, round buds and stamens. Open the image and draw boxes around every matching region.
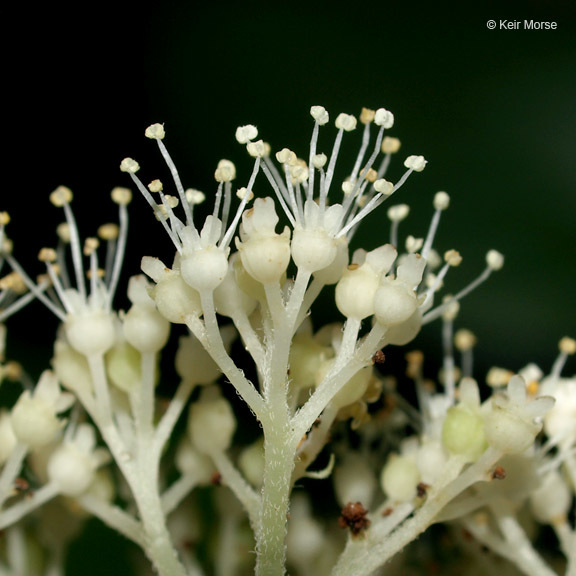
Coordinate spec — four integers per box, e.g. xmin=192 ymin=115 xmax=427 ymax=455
xmin=0 ymin=106 xmax=576 ymax=576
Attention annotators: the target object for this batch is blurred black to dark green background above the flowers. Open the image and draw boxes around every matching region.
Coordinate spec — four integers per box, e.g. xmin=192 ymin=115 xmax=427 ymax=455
xmin=0 ymin=0 xmax=576 ymax=574
